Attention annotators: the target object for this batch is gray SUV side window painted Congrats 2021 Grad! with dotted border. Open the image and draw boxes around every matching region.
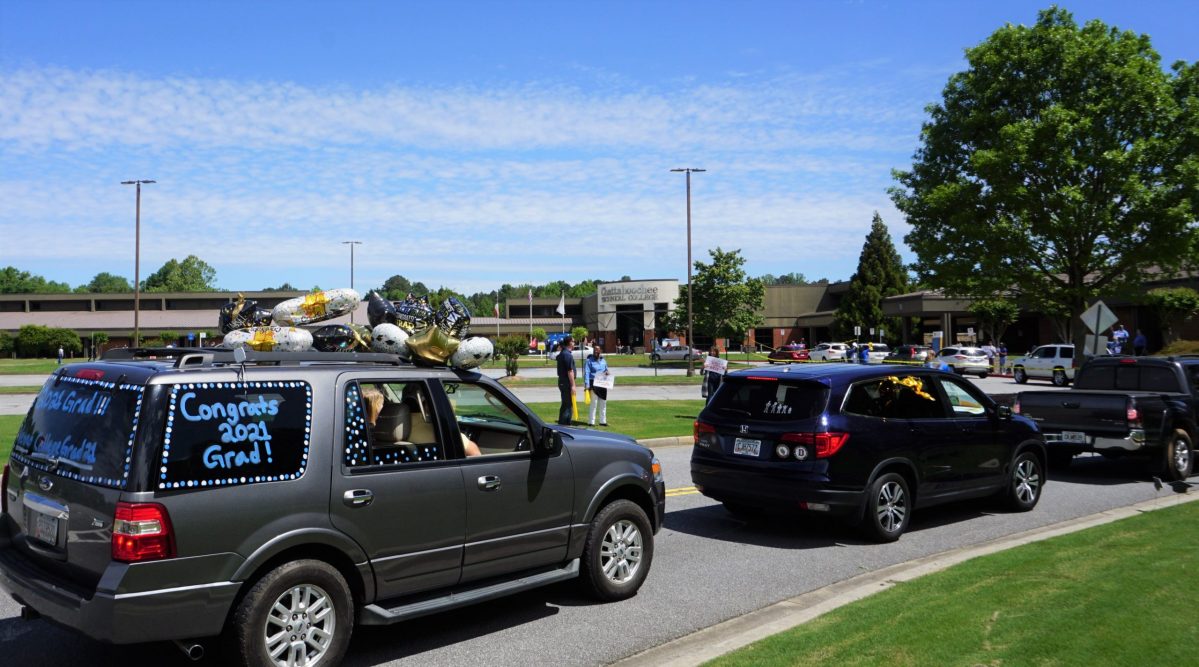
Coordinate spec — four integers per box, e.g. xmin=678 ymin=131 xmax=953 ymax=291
xmin=158 ymin=381 xmax=312 ymax=489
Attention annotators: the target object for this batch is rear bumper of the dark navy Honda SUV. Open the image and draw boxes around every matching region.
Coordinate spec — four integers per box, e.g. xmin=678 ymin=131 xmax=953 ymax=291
xmin=691 ymin=459 xmax=866 ymax=515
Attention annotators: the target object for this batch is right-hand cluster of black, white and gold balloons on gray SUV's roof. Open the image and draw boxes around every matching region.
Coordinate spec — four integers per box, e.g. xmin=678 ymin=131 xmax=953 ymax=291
xmin=367 ymin=293 xmax=494 ymax=368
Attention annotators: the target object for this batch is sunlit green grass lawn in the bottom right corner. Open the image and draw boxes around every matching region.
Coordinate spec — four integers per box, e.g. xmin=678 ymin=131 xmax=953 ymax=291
xmin=707 ymin=503 xmax=1199 ymax=667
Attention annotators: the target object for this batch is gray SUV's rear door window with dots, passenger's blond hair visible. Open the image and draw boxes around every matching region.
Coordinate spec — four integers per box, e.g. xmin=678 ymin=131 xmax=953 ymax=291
xmin=344 ymin=381 xmax=446 ymax=467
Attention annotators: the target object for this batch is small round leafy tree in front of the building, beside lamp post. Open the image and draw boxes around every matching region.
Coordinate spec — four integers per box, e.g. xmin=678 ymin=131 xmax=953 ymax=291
xmin=665 ymin=247 xmax=766 ymax=344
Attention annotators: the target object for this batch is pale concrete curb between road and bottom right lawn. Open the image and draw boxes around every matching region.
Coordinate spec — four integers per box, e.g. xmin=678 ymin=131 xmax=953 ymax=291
xmin=611 ymin=494 xmax=1199 ymax=667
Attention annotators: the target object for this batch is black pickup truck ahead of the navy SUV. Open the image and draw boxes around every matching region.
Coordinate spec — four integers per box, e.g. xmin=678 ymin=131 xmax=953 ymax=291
xmin=1012 ymin=355 xmax=1199 ymax=481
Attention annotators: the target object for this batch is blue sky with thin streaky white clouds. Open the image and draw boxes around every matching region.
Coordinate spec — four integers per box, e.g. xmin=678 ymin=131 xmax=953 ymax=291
xmin=0 ymin=0 xmax=1199 ymax=293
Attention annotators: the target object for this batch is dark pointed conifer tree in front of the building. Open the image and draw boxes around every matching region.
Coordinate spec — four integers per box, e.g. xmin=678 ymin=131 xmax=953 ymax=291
xmin=833 ymin=211 xmax=908 ymax=339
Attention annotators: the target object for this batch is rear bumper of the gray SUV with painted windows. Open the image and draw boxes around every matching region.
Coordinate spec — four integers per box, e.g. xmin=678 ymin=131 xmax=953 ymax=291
xmin=0 ymin=548 xmax=240 ymax=644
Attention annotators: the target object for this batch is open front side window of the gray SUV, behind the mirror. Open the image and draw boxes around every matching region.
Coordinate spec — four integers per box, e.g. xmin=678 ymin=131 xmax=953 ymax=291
xmin=444 ymin=383 xmax=532 ymax=457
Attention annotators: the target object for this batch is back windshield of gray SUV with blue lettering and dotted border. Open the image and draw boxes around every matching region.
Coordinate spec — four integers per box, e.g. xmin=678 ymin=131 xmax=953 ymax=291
xmin=12 ymin=375 xmax=144 ymax=488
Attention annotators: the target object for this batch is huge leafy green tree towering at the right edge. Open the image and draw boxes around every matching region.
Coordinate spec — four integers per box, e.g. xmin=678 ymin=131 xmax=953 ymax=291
xmin=891 ymin=8 xmax=1199 ymax=342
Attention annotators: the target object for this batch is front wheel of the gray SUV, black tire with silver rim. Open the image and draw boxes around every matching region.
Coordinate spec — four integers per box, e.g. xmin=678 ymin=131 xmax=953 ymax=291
xmin=579 ymin=500 xmax=653 ymax=602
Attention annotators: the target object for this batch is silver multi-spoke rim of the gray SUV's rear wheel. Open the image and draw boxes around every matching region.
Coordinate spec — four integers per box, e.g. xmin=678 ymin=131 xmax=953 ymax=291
xmin=263 ymin=584 xmax=337 ymax=667
